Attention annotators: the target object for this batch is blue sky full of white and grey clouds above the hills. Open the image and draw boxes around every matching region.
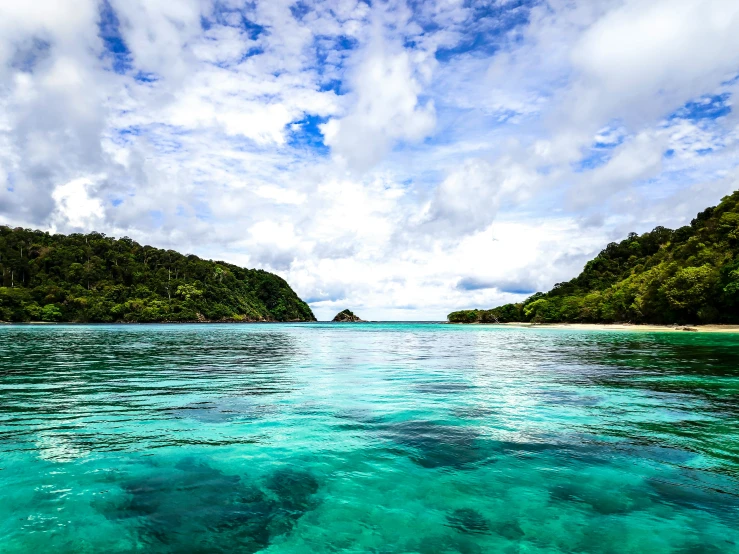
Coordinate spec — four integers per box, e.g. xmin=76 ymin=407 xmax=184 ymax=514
xmin=0 ymin=0 xmax=739 ymax=320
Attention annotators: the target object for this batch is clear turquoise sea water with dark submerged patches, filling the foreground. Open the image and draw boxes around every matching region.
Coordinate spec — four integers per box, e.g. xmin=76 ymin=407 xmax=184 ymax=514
xmin=0 ymin=324 xmax=739 ymax=554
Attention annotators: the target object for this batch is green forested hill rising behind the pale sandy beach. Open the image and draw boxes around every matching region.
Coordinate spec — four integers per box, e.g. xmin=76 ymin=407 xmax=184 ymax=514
xmin=448 ymin=191 xmax=739 ymax=324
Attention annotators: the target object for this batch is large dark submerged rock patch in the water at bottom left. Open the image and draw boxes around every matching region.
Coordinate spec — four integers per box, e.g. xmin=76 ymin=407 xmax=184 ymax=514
xmin=98 ymin=459 xmax=319 ymax=554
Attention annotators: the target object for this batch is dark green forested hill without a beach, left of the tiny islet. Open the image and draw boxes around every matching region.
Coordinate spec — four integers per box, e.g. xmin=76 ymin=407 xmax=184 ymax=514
xmin=0 ymin=226 xmax=315 ymax=322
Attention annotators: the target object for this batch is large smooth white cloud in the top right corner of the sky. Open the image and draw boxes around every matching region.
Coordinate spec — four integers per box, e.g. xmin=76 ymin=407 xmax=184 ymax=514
xmin=572 ymin=0 xmax=739 ymax=119
